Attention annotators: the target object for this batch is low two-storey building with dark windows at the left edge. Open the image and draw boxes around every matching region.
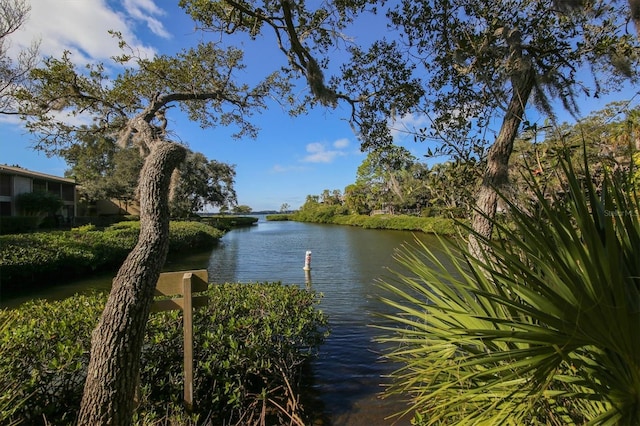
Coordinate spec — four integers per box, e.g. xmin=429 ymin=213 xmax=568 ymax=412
xmin=0 ymin=165 xmax=77 ymax=222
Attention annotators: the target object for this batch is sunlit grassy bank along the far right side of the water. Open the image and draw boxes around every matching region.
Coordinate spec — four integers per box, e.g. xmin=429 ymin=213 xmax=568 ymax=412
xmin=267 ymin=209 xmax=457 ymax=235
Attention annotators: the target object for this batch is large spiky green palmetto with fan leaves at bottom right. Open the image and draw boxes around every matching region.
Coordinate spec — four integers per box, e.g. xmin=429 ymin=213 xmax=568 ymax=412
xmin=380 ymin=156 xmax=640 ymax=425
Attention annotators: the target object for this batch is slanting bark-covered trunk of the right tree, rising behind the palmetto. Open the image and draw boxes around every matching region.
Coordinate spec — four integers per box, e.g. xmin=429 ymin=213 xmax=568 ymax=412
xmin=468 ymin=58 xmax=535 ymax=258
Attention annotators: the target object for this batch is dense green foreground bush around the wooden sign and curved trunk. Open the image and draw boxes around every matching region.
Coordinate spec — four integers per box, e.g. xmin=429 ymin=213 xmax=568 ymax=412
xmin=0 ymin=283 xmax=326 ymax=425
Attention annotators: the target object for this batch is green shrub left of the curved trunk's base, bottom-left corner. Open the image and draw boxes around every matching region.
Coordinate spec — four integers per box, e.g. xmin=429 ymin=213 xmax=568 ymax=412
xmin=0 ymin=295 xmax=106 ymax=424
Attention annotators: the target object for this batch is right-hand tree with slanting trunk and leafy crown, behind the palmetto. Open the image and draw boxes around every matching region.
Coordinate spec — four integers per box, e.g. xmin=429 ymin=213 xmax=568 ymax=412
xmin=380 ymin=0 xmax=638 ymax=253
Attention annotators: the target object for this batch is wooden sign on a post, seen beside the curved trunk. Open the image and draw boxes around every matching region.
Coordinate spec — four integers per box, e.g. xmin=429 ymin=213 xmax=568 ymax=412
xmin=151 ymin=269 xmax=209 ymax=411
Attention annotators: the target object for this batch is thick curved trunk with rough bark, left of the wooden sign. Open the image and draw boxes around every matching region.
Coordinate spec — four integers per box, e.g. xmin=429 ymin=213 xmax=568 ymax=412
xmin=78 ymin=142 xmax=186 ymax=426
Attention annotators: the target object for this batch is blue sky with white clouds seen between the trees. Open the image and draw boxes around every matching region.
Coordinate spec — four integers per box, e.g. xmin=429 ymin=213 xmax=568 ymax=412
xmin=0 ymin=0 xmax=637 ymax=211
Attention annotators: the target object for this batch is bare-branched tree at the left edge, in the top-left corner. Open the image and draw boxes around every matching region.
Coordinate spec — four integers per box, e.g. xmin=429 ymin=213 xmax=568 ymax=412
xmin=0 ymin=0 xmax=38 ymax=114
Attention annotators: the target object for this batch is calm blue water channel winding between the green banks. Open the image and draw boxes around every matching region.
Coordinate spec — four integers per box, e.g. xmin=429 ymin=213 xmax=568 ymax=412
xmin=2 ymin=217 xmax=450 ymax=426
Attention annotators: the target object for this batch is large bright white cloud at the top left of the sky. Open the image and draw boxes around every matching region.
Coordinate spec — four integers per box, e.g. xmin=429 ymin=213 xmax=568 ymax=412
xmin=11 ymin=0 xmax=169 ymax=64
